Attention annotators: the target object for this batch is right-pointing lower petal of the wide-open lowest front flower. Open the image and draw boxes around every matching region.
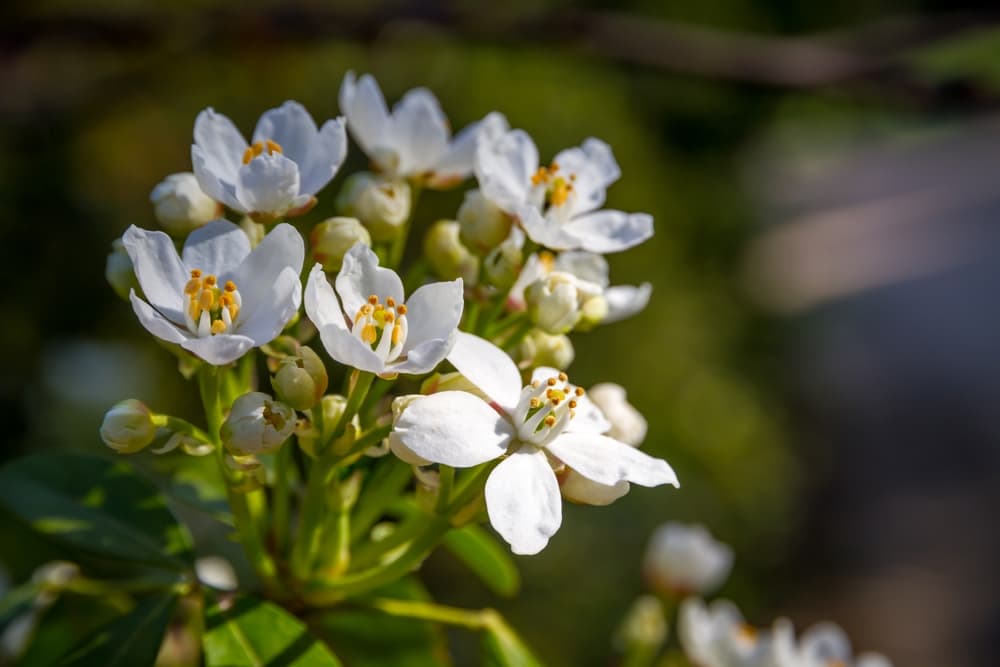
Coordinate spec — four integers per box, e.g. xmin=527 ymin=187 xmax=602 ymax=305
xmin=548 ymin=432 xmax=680 ymax=486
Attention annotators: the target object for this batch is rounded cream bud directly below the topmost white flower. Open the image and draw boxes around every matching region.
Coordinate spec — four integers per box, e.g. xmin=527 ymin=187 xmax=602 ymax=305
xmin=337 ymin=171 xmax=410 ymax=241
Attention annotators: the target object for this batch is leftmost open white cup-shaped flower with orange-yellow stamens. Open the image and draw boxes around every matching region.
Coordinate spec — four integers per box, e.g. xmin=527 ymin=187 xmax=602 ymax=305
xmin=122 ymin=220 xmax=305 ymax=366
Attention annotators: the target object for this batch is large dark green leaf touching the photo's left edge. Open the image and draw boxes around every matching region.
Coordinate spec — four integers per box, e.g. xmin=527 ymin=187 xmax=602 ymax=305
xmin=0 ymin=452 xmax=192 ymax=569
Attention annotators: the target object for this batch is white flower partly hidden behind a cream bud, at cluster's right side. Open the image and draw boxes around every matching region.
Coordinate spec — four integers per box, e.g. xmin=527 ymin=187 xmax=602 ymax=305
xmin=507 ymin=251 xmax=653 ymax=324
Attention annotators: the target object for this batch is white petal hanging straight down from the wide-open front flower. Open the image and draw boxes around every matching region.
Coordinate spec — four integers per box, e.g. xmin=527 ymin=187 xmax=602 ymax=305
xmin=485 ymin=447 xmax=562 ymax=555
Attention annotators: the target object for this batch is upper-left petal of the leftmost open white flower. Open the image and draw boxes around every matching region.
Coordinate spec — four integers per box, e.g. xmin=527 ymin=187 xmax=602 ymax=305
xmin=122 ymin=225 xmax=190 ymax=324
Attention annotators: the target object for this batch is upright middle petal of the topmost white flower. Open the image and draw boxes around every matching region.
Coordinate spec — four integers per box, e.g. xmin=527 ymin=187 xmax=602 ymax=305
xmin=392 ymin=88 xmax=451 ymax=176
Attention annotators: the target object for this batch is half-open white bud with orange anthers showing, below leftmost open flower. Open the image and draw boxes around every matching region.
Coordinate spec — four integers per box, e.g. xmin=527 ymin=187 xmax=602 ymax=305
xmin=219 ymin=391 xmax=295 ymax=456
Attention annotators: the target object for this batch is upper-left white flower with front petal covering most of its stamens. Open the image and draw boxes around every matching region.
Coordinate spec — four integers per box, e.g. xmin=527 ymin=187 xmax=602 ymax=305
xmin=191 ymin=101 xmax=347 ymax=220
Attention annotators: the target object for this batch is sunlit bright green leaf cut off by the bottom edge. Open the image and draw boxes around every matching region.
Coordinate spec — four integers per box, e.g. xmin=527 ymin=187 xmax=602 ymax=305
xmin=202 ymin=597 xmax=340 ymax=667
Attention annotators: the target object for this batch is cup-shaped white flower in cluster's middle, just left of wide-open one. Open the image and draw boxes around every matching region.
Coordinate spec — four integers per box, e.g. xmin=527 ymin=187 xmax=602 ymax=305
xmin=306 ymin=244 xmax=463 ymax=377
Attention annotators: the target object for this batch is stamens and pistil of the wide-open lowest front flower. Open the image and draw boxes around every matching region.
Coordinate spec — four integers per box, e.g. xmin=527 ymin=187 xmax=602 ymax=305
xmin=511 ymin=373 xmax=583 ymax=447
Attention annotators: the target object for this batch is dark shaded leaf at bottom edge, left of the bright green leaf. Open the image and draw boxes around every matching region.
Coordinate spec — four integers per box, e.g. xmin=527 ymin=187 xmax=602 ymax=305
xmin=58 ymin=595 xmax=177 ymax=667
